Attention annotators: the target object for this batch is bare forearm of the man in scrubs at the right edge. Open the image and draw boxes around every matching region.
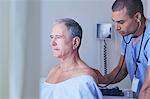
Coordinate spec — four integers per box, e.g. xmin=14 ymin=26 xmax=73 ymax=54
xmin=139 ymin=65 xmax=150 ymax=99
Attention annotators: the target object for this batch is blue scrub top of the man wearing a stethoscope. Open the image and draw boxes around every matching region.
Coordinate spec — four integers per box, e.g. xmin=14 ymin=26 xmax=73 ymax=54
xmin=121 ymin=20 xmax=150 ymax=95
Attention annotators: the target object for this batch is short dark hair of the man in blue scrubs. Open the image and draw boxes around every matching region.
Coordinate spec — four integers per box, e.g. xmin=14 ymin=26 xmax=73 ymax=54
xmin=112 ymin=0 xmax=144 ymax=17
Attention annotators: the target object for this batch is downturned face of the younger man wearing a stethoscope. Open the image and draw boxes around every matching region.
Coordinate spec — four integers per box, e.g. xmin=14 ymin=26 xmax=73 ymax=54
xmin=112 ymin=7 xmax=138 ymax=36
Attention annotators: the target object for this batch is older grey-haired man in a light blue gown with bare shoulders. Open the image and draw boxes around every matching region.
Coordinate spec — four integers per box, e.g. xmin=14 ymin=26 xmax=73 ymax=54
xmin=40 ymin=18 xmax=102 ymax=99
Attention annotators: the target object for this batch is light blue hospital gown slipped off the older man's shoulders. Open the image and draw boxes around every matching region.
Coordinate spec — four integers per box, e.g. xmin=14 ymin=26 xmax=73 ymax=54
xmin=40 ymin=75 xmax=103 ymax=99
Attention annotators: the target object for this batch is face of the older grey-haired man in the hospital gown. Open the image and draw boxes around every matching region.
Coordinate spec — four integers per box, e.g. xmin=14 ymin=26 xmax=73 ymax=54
xmin=50 ymin=23 xmax=73 ymax=59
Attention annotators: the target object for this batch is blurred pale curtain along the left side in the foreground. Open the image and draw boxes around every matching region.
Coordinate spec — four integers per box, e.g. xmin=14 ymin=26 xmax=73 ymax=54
xmin=0 ymin=0 xmax=40 ymax=99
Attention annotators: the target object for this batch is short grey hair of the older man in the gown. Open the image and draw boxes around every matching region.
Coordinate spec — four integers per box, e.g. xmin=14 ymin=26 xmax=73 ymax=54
xmin=56 ymin=18 xmax=82 ymax=48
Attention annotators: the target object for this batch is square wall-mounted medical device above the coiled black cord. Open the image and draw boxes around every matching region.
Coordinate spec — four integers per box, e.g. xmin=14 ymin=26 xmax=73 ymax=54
xmin=97 ymin=23 xmax=112 ymax=39
